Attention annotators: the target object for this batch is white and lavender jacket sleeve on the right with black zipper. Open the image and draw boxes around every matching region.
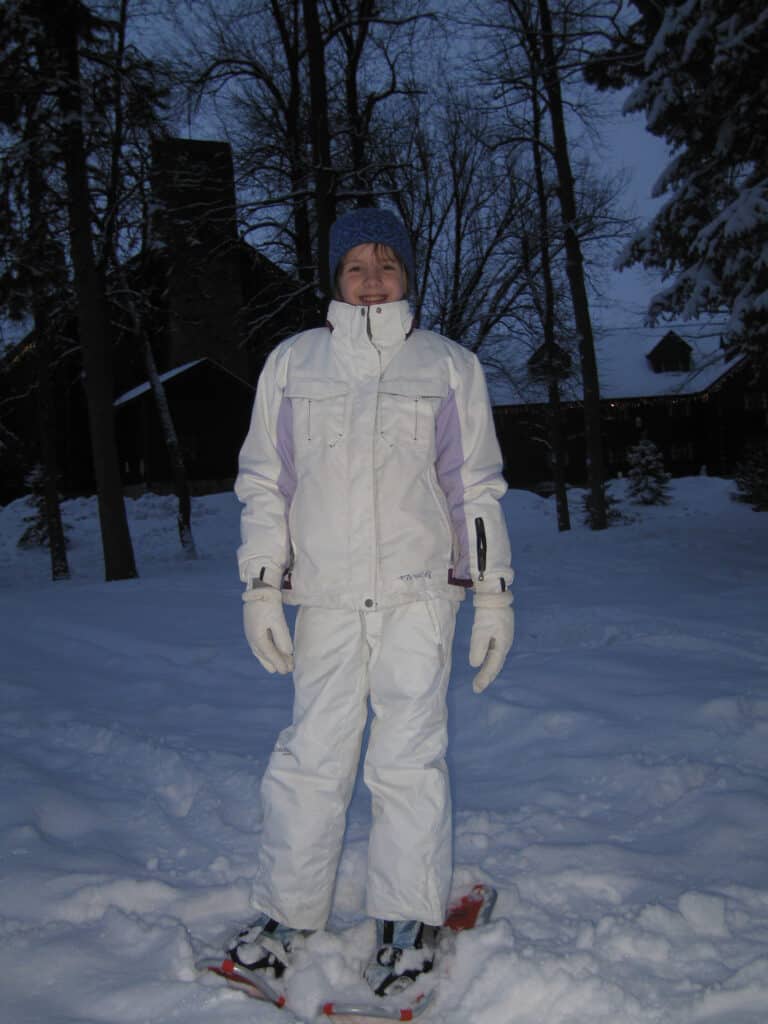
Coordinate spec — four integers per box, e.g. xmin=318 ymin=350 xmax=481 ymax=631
xmin=435 ymin=349 xmax=514 ymax=594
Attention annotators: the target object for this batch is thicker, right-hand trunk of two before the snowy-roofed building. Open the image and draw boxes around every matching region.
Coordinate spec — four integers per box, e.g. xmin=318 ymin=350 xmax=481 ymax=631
xmin=538 ymin=0 xmax=607 ymax=529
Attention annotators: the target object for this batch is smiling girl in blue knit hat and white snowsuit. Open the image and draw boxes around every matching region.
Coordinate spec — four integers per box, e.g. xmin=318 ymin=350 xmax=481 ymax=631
xmin=228 ymin=203 xmax=514 ymax=995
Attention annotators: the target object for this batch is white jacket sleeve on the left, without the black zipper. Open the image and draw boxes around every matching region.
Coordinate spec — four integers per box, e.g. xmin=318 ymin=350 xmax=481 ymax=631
xmin=234 ymin=345 xmax=296 ymax=588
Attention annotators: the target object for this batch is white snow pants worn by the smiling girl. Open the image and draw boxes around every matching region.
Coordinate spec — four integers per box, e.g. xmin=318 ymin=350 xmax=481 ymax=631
xmin=252 ymin=599 xmax=457 ymax=930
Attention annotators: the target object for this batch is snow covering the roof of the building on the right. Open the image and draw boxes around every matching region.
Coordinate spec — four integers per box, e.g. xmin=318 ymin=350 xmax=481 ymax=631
xmin=486 ymin=322 xmax=740 ymax=406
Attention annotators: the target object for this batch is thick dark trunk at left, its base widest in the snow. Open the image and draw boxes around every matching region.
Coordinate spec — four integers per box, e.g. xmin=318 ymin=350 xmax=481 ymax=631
xmin=55 ymin=12 xmax=137 ymax=581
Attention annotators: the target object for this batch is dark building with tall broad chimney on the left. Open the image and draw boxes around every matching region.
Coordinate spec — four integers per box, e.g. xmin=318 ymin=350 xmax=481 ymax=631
xmin=0 ymin=139 xmax=321 ymax=501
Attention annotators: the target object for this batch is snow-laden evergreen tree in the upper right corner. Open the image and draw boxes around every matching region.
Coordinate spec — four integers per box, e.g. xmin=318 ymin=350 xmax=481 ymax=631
xmin=588 ymin=0 xmax=768 ymax=359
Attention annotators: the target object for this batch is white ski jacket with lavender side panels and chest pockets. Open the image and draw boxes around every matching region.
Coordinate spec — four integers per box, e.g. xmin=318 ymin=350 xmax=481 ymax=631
xmin=236 ymin=301 xmax=513 ymax=611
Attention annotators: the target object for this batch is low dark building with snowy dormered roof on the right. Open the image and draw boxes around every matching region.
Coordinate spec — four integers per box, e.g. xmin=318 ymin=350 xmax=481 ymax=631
xmin=490 ymin=325 xmax=768 ymax=492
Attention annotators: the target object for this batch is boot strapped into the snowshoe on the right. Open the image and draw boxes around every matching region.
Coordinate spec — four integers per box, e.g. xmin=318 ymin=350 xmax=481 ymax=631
xmin=364 ymin=921 xmax=439 ymax=996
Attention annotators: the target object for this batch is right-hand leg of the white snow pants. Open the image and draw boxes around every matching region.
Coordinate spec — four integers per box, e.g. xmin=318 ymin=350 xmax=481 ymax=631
xmin=365 ymin=600 xmax=457 ymax=925
